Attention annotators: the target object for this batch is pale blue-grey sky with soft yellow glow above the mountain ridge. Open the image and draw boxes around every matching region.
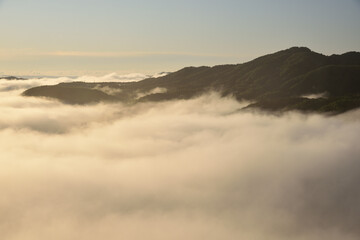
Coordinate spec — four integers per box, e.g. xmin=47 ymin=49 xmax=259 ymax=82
xmin=0 ymin=0 xmax=360 ymax=76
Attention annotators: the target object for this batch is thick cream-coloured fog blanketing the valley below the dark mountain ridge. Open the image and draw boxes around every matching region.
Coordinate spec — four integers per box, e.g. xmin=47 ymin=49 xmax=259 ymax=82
xmin=0 ymin=74 xmax=360 ymax=240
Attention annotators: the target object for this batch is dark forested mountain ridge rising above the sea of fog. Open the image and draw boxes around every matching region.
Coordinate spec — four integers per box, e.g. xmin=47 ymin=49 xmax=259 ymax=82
xmin=24 ymin=47 xmax=360 ymax=113
